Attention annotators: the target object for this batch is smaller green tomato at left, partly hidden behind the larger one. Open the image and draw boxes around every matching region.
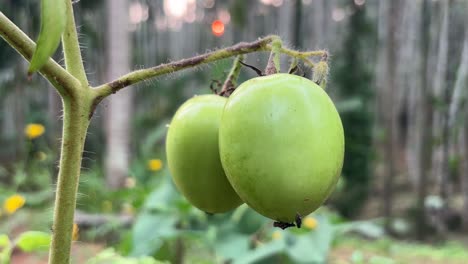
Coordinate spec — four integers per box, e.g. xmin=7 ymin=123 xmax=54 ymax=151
xmin=166 ymin=95 xmax=243 ymax=213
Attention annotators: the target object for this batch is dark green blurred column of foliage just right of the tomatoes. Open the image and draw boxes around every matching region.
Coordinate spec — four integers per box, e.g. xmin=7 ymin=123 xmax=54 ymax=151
xmin=332 ymin=2 xmax=374 ymax=217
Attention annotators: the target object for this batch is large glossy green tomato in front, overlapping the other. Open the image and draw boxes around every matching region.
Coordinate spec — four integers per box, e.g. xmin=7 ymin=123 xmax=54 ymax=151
xmin=219 ymin=74 xmax=344 ymax=223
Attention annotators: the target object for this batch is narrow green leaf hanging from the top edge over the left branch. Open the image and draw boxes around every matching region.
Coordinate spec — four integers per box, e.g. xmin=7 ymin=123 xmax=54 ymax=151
xmin=28 ymin=0 xmax=67 ymax=73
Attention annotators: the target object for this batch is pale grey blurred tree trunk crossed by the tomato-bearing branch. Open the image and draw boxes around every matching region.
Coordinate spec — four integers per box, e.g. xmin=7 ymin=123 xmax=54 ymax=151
xmin=105 ymin=0 xmax=133 ymax=189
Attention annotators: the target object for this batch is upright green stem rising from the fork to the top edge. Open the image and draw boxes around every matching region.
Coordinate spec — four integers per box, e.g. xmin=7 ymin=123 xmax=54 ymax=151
xmin=62 ymin=0 xmax=88 ymax=87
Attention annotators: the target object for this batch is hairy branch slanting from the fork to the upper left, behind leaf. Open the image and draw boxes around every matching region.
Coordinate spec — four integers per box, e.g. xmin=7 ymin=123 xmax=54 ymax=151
xmin=0 ymin=12 xmax=79 ymax=96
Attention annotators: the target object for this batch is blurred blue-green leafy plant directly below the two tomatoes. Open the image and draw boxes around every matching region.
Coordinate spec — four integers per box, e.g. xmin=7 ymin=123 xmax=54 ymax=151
xmin=126 ymin=175 xmax=339 ymax=263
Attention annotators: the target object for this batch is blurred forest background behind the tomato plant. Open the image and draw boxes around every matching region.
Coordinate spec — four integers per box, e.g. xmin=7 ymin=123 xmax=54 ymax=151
xmin=0 ymin=0 xmax=468 ymax=263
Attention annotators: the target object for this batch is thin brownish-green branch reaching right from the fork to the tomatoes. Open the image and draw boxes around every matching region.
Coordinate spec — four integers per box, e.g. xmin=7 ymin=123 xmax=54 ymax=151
xmin=93 ymin=36 xmax=278 ymax=97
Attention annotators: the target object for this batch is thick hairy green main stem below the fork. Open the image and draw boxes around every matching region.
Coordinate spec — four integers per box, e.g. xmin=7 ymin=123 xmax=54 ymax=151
xmin=49 ymin=94 xmax=91 ymax=264
